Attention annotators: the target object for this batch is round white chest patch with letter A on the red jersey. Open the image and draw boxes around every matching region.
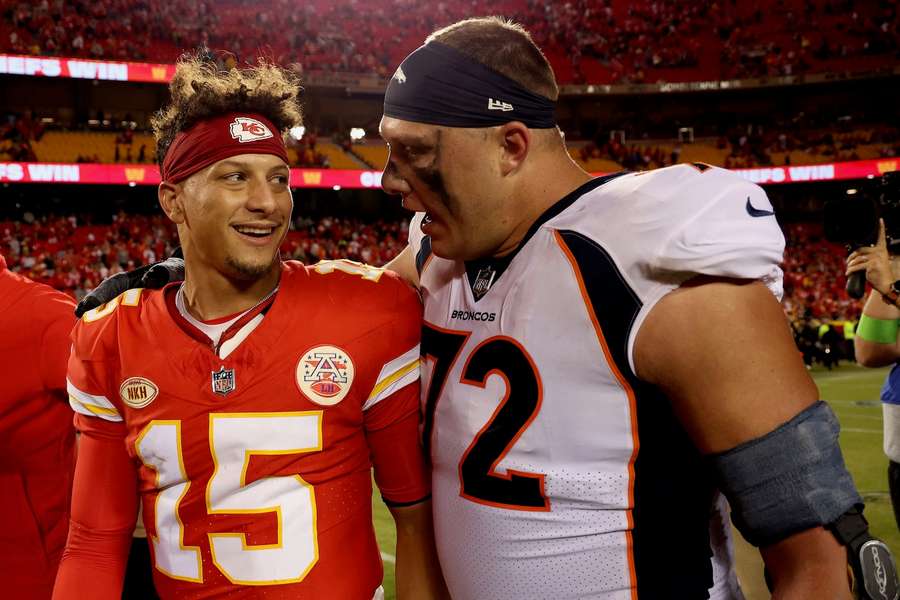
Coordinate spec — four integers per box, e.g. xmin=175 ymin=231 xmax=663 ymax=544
xmin=297 ymin=346 xmax=354 ymax=406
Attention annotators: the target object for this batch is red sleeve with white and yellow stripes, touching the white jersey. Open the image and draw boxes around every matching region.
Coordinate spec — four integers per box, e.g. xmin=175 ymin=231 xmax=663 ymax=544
xmin=363 ymin=281 xmax=431 ymax=506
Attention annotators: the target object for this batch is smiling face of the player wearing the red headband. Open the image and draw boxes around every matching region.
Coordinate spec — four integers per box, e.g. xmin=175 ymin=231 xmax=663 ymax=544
xmin=179 ymin=154 xmax=294 ymax=281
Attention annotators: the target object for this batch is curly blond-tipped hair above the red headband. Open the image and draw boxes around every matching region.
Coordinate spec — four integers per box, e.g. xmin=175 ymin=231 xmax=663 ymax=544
xmin=150 ymin=52 xmax=303 ymax=167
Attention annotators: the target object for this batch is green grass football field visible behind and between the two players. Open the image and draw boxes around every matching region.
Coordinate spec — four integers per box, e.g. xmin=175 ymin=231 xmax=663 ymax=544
xmin=374 ymin=365 xmax=900 ymax=600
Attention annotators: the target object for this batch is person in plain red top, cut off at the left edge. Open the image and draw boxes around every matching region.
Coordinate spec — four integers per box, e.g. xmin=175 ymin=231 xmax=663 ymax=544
xmin=0 ymin=256 xmax=75 ymax=600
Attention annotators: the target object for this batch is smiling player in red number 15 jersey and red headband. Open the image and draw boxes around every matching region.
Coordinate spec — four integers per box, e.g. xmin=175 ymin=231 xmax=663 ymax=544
xmin=54 ymin=59 xmax=445 ymax=600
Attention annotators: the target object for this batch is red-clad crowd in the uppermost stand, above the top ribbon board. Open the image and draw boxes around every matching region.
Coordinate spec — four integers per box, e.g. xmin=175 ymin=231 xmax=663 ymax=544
xmin=0 ymin=0 xmax=900 ymax=83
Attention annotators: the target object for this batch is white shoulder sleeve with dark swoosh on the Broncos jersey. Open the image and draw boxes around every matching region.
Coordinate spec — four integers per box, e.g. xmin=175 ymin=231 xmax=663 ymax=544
xmin=553 ymin=164 xmax=784 ymax=376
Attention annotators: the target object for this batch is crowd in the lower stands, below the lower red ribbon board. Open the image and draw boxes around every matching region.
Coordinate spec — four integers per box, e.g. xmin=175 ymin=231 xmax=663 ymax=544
xmin=0 ymin=211 xmax=860 ymax=321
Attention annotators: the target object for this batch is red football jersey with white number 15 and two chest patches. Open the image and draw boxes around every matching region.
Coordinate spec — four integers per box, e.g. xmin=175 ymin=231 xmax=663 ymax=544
xmin=69 ymin=261 xmax=430 ymax=600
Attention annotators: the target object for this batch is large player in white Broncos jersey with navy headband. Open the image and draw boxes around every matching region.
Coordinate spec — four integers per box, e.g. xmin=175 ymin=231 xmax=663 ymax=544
xmin=380 ymin=18 xmax=888 ymax=600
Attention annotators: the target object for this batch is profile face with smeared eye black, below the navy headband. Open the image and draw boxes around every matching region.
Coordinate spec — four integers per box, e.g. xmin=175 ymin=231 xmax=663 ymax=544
xmin=380 ymin=117 xmax=505 ymax=260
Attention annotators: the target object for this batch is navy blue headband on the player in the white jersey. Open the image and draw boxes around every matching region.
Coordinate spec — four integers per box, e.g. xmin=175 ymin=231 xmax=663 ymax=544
xmin=384 ymin=42 xmax=556 ymax=129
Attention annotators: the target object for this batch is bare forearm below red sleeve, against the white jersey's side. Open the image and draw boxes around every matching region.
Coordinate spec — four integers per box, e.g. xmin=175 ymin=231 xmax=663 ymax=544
xmin=391 ymin=502 xmax=450 ymax=600
